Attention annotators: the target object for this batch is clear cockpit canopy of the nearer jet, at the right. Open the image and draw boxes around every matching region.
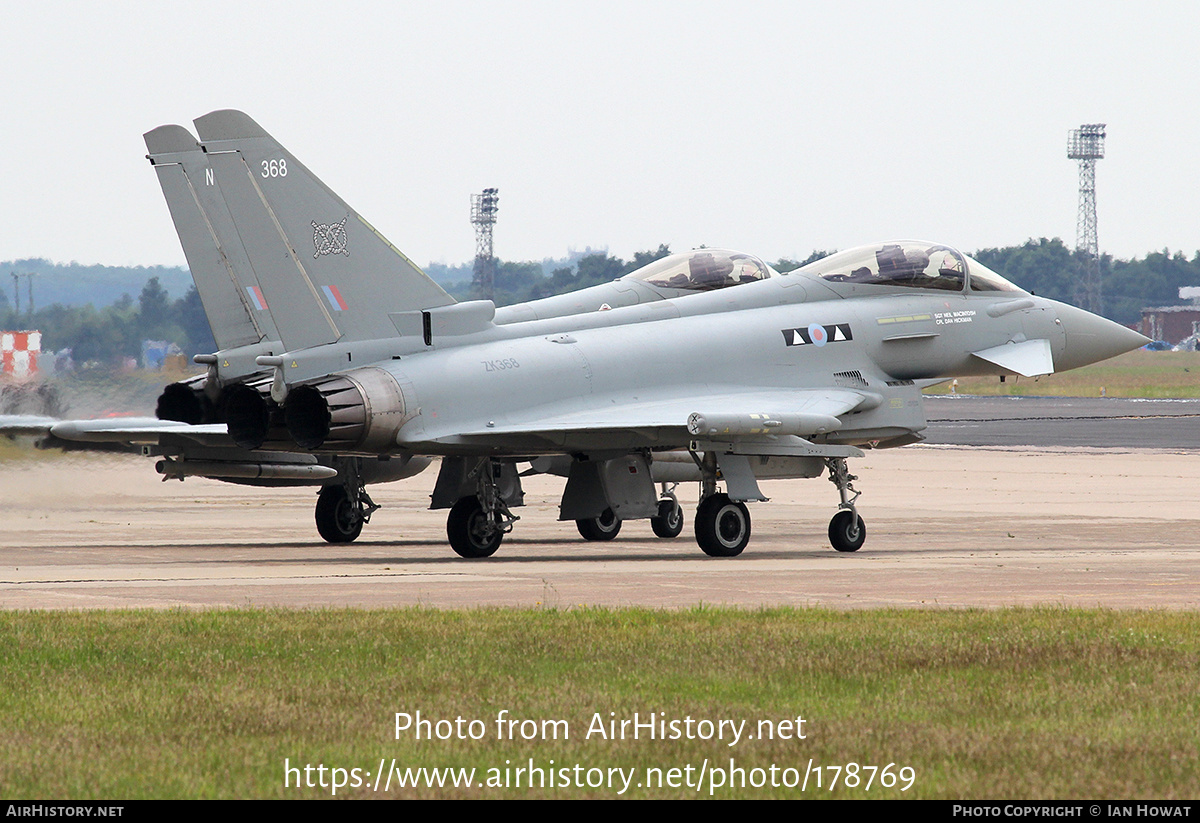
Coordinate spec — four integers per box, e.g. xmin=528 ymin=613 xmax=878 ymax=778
xmin=804 ymin=241 xmax=1021 ymax=292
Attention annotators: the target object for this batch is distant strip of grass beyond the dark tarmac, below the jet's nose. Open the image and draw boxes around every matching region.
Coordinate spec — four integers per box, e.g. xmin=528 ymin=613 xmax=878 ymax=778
xmin=925 ymin=349 xmax=1200 ymax=397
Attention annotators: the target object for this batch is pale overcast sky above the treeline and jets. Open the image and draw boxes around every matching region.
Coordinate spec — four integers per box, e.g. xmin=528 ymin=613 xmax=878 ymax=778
xmin=0 ymin=0 xmax=1200 ymax=265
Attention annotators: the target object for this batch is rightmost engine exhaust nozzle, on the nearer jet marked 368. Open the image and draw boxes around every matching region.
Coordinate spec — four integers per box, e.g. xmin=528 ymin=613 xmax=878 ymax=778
xmin=283 ymin=368 xmax=408 ymax=455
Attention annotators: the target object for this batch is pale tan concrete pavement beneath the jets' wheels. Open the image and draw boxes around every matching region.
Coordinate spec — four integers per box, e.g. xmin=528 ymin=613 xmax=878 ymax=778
xmin=0 ymin=410 xmax=1200 ymax=608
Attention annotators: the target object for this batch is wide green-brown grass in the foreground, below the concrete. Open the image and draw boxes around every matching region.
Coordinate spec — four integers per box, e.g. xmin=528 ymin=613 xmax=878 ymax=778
xmin=0 ymin=607 xmax=1200 ymax=799
